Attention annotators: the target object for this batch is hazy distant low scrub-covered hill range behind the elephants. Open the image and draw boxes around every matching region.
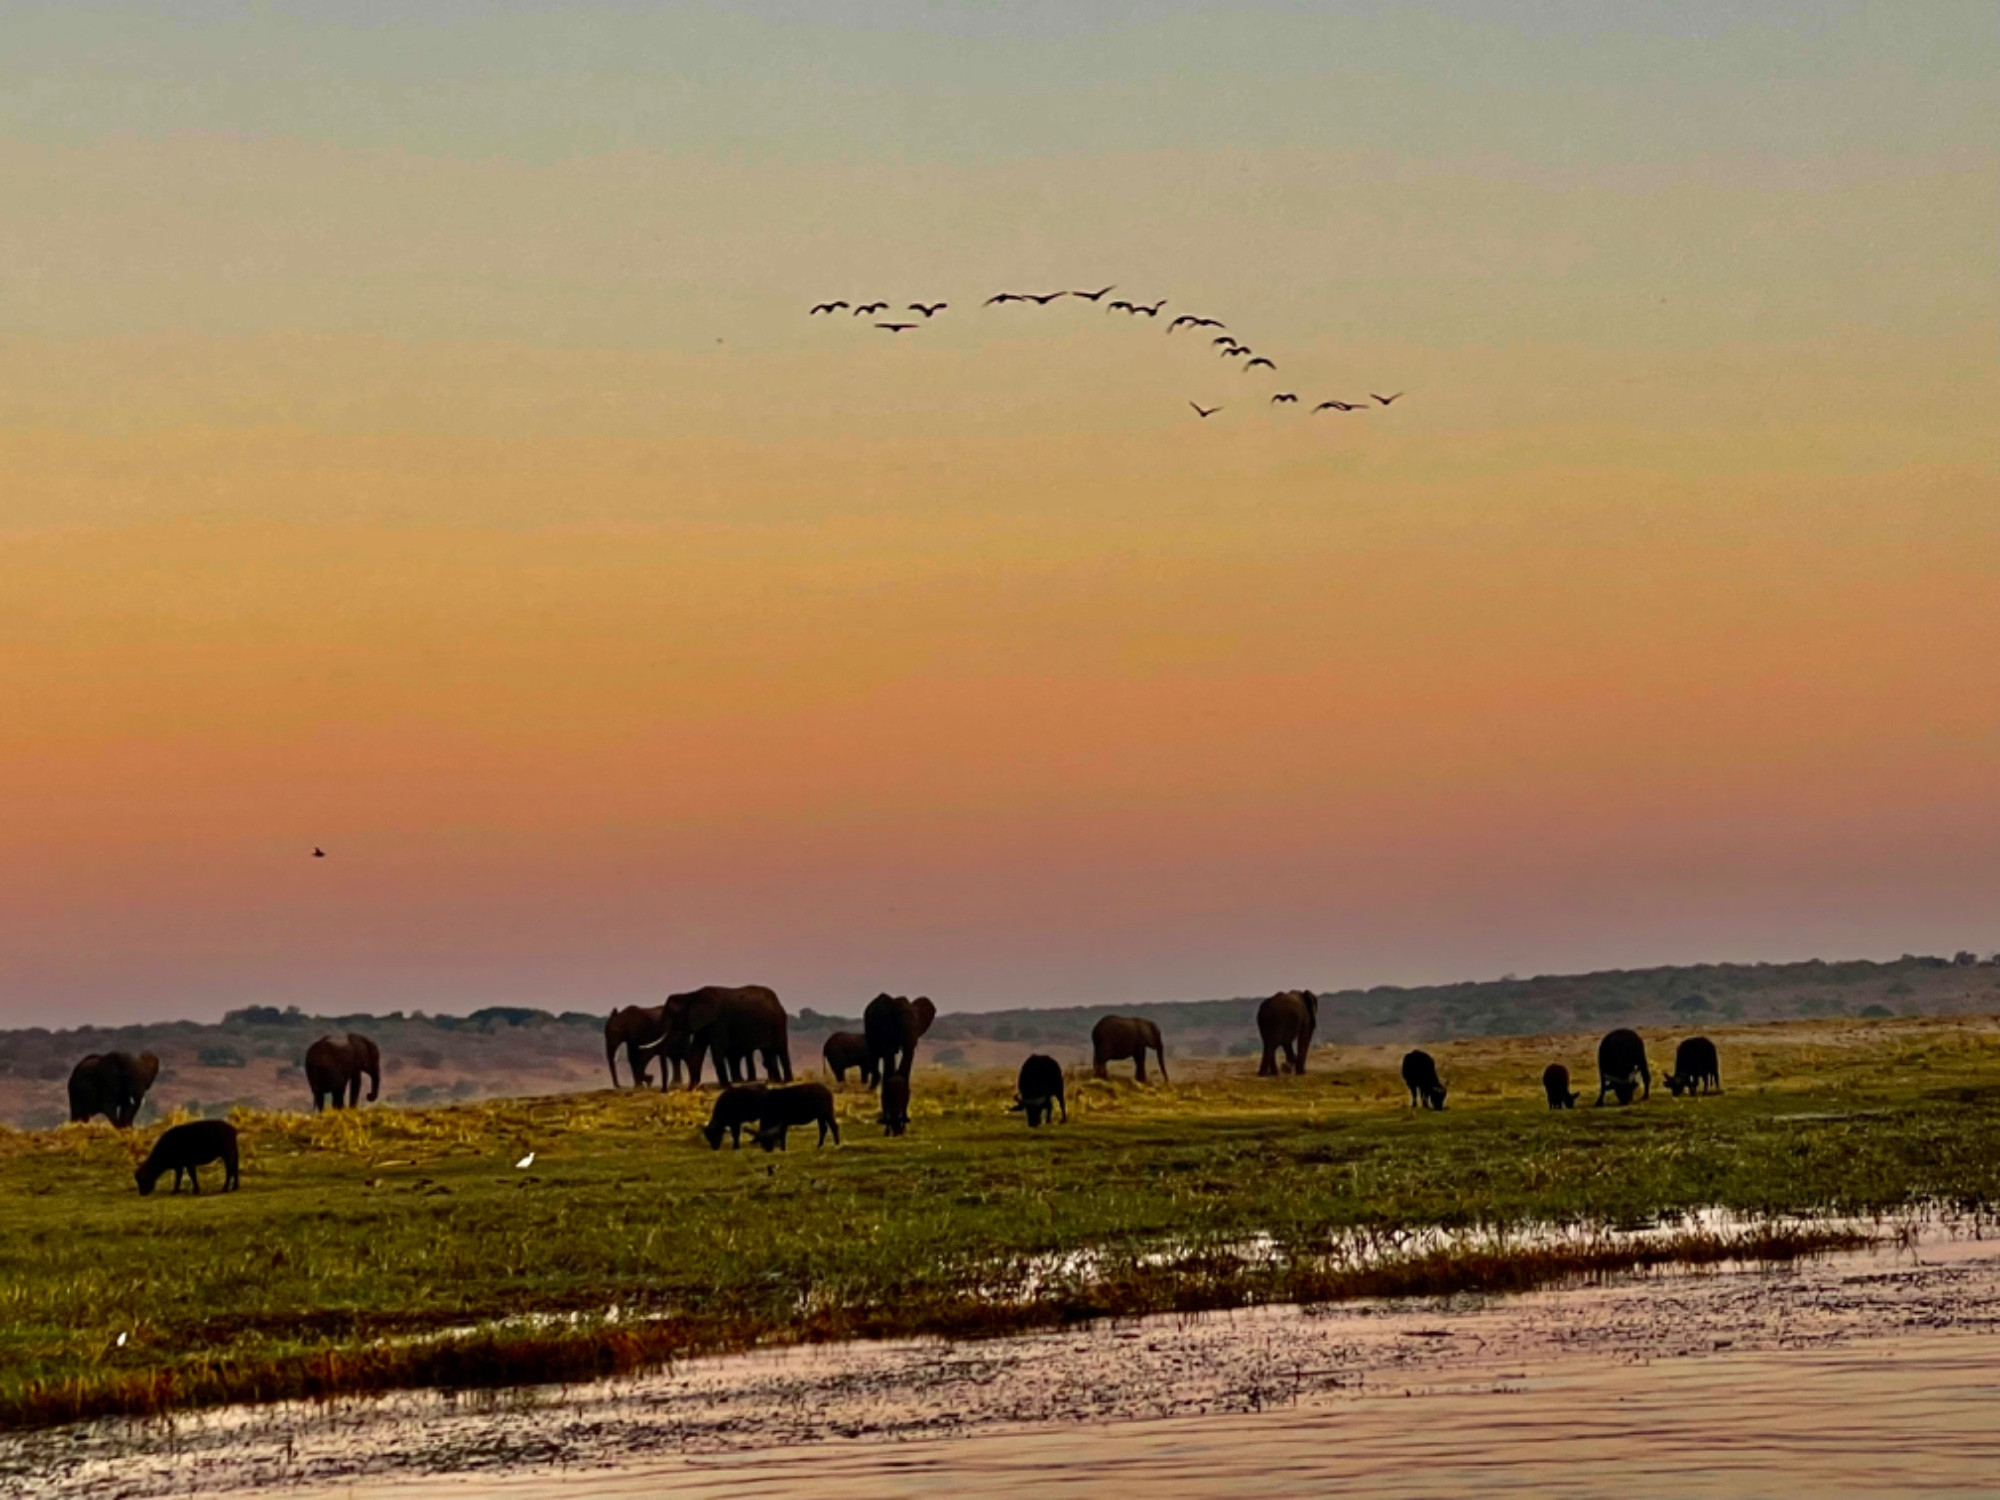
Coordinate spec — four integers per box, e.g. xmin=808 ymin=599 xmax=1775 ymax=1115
xmin=0 ymin=954 xmax=2000 ymax=1128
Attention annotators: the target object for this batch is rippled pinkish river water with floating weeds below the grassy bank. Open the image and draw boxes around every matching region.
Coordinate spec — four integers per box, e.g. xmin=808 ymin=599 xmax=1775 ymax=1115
xmin=0 ymin=1220 xmax=2000 ymax=1500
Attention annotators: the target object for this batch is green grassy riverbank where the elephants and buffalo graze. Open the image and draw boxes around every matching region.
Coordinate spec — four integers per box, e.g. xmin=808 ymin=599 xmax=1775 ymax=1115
xmin=0 ymin=1020 xmax=2000 ymax=1426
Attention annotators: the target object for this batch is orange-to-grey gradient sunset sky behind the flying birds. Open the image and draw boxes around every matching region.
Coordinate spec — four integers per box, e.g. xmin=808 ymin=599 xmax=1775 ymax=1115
xmin=0 ymin=0 xmax=2000 ymax=1024
